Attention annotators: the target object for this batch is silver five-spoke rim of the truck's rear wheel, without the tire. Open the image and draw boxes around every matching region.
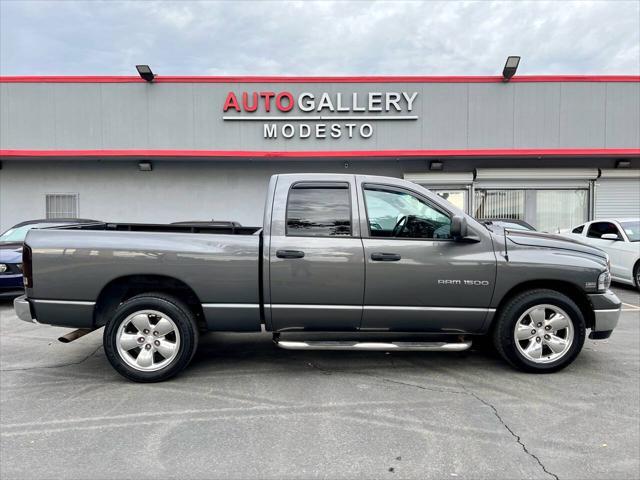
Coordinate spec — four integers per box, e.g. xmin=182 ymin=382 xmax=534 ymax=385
xmin=116 ymin=310 xmax=180 ymax=372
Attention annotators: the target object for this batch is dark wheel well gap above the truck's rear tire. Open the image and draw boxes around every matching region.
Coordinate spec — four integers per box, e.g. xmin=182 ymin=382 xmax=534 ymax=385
xmin=93 ymin=275 xmax=205 ymax=328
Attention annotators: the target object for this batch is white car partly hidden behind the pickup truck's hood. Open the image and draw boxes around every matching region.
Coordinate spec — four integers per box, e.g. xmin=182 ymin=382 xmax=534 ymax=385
xmin=569 ymin=218 xmax=640 ymax=290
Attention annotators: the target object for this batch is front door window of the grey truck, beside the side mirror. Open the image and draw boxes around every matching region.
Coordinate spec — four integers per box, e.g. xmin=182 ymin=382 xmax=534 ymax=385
xmin=364 ymin=186 xmax=452 ymax=240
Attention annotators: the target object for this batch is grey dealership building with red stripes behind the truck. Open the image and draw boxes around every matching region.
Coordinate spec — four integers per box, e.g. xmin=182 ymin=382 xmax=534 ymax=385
xmin=0 ymin=76 xmax=640 ymax=231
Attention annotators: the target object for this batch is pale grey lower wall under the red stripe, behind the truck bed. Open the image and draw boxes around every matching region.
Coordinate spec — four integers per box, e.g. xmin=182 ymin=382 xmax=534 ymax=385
xmin=0 ymin=160 xmax=404 ymax=231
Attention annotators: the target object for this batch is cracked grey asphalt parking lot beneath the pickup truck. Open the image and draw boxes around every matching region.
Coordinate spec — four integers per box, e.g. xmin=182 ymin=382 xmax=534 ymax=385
xmin=0 ymin=287 xmax=640 ymax=479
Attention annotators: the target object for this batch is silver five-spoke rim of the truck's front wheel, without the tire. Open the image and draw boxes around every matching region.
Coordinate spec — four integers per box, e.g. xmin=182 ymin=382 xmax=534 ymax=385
xmin=514 ymin=304 xmax=574 ymax=363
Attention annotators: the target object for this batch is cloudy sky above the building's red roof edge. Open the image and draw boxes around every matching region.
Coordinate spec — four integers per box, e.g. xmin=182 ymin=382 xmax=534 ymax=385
xmin=0 ymin=0 xmax=640 ymax=75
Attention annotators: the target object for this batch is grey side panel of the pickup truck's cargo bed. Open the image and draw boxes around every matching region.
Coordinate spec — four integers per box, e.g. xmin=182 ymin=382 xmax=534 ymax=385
xmin=25 ymin=223 xmax=261 ymax=330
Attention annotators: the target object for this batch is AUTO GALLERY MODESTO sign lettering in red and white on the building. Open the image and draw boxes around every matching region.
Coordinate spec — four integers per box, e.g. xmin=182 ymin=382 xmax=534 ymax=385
xmin=222 ymin=91 xmax=418 ymax=139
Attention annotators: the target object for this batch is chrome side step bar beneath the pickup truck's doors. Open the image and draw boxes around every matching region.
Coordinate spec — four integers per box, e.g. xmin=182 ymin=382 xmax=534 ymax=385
xmin=274 ymin=339 xmax=471 ymax=352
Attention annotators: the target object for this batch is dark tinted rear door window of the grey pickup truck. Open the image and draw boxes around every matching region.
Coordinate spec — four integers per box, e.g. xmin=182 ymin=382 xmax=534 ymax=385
xmin=287 ymin=183 xmax=351 ymax=237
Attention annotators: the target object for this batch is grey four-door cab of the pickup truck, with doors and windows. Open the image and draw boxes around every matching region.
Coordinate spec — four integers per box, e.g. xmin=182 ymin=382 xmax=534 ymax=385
xmin=263 ymin=174 xmax=497 ymax=333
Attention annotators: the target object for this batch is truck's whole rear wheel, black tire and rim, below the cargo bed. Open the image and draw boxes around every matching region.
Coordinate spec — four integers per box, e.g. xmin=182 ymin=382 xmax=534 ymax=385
xmin=103 ymin=293 xmax=198 ymax=382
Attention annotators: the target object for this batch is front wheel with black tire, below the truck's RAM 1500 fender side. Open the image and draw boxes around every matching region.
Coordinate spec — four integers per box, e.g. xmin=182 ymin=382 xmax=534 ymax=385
xmin=493 ymin=289 xmax=586 ymax=373
